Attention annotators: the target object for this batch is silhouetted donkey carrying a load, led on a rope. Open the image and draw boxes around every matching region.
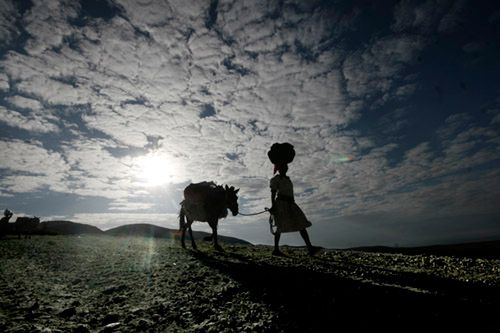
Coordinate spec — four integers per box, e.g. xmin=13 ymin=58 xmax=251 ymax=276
xmin=179 ymin=182 xmax=239 ymax=251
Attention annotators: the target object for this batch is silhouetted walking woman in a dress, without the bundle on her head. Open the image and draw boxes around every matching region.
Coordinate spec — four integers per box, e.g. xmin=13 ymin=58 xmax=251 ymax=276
xmin=270 ymin=163 xmax=321 ymax=256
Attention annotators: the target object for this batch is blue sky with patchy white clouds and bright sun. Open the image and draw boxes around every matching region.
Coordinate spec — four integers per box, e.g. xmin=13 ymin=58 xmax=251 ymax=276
xmin=0 ymin=0 xmax=500 ymax=248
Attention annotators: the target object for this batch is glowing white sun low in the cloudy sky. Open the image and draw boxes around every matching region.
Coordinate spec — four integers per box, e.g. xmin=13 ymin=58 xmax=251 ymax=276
xmin=136 ymin=153 xmax=174 ymax=186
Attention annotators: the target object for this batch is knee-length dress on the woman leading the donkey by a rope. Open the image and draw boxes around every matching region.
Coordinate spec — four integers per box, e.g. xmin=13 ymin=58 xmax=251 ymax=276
xmin=270 ymin=175 xmax=312 ymax=233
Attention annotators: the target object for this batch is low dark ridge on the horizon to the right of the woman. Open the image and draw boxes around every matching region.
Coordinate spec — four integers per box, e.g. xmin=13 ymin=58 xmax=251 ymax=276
xmin=350 ymin=240 xmax=500 ymax=259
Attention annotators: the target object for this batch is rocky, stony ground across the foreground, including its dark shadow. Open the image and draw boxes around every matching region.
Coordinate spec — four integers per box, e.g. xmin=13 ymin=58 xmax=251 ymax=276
xmin=0 ymin=236 xmax=500 ymax=332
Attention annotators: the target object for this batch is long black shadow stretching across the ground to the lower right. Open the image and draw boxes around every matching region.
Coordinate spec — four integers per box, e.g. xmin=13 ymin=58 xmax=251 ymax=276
xmin=192 ymin=251 xmax=499 ymax=332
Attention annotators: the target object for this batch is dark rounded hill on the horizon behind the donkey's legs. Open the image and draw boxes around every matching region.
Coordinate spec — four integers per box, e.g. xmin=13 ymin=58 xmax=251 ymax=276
xmin=104 ymin=223 xmax=252 ymax=245
